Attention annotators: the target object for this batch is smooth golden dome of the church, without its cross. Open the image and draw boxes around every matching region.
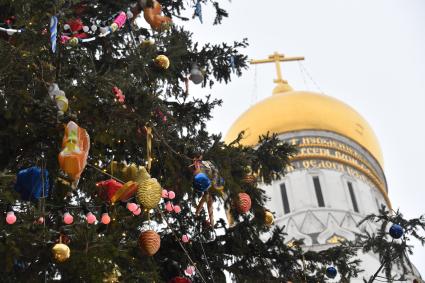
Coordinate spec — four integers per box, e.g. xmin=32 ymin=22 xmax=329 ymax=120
xmin=225 ymin=91 xmax=384 ymax=167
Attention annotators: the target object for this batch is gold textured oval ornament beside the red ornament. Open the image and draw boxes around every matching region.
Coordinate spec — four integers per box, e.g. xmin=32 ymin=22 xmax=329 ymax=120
xmin=136 ymin=178 xmax=162 ymax=209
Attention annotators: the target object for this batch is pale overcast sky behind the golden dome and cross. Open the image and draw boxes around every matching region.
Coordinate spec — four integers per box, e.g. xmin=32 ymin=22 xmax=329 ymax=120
xmin=180 ymin=0 xmax=425 ymax=276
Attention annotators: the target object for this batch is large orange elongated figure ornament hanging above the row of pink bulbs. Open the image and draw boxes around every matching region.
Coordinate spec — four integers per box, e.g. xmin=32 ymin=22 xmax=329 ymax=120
xmin=59 ymin=121 xmax=90 ymax=188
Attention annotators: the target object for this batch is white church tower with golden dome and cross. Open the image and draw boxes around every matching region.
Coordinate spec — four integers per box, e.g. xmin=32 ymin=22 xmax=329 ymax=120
xmin=225 ymin=53 xmax=416 ymax=282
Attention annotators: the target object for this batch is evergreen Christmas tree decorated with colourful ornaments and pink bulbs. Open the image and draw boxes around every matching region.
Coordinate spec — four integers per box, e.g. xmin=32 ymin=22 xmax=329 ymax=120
xmin=0 ymin=0 xmax=423 ymax=282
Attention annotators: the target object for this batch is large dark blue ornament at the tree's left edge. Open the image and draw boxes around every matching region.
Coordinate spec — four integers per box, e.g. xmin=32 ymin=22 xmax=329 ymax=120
xmin=15 ymin=166 xmax=50 ymax=201
